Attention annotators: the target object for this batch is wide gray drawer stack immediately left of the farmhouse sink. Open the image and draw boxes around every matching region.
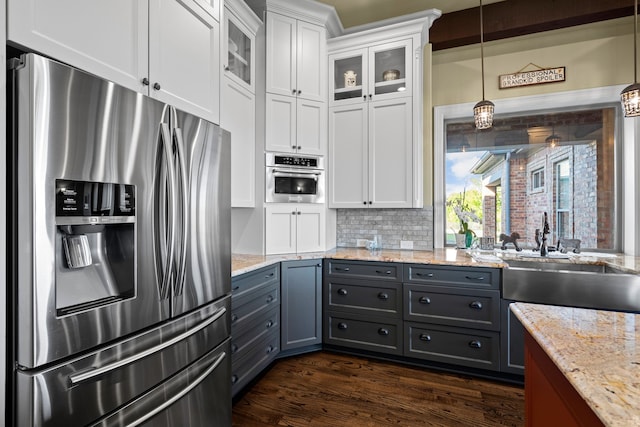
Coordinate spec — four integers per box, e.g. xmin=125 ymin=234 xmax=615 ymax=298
xmin=403 ymin=264 xmax=500 ymax=371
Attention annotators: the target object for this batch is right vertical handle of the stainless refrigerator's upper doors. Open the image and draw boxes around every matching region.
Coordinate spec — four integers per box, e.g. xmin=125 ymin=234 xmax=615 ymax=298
xmin=173 ymin=127 xmax=190 ymax=296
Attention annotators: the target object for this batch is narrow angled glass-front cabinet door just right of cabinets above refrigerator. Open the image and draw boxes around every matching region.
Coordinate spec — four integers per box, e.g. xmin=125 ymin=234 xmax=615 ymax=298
xmin=224 ymin=15 xmax=255 ymax=92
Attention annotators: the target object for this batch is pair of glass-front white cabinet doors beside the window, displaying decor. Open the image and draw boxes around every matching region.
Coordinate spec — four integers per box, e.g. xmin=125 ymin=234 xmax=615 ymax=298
xmin=329 ymin=39 xmax=413 ymax=105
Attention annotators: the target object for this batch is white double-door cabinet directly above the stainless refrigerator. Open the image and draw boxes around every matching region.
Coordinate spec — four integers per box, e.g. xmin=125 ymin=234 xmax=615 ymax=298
xmin=7 ymin=0 xmax=220 ymax=123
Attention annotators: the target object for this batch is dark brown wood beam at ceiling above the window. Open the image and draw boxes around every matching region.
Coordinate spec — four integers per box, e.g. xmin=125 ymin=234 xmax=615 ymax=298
xmin=429 ymin=0 xmax=634 ymax=51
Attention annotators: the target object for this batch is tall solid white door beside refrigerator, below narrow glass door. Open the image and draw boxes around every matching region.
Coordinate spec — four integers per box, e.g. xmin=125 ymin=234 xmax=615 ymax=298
xmin=220 ymin=80 xmax=256 ymax=207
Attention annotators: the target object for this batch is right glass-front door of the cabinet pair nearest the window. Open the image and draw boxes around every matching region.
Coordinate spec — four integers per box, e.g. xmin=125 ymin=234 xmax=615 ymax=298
xmin=369 ymin=40 xmax=413 ymax=100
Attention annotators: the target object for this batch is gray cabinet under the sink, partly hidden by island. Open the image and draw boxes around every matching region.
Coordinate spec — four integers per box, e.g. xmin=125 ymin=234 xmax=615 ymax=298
xmin=500 ymin=299 xmax=524 ymax=375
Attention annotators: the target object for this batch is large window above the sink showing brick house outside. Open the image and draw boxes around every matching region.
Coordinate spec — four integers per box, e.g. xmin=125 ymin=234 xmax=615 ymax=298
xmin=444 ymin=104 xmax=622 ymax=250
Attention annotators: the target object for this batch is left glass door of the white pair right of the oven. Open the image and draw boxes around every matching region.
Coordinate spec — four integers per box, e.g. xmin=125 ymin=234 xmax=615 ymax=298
xmin=329 ymin=49 xmax=368 ymax=104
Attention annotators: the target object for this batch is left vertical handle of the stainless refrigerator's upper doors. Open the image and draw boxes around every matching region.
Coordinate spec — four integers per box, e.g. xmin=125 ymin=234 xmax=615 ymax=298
xmin=156 ymin=123 xmax=177 ymax=299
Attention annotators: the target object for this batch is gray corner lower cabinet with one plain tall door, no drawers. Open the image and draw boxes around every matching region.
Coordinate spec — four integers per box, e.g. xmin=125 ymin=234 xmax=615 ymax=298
xmin=281 ymin=259 xmax=322 ymax=354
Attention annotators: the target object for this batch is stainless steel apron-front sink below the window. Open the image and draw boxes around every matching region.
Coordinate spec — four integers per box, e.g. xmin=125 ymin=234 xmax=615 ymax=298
xmin=502 ymin=260 xmax=640 ymax=312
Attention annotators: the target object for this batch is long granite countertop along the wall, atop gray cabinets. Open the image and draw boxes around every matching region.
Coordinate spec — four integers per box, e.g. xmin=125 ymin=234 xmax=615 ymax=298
xmin=231 ymin=248 xmax=640 ymax=276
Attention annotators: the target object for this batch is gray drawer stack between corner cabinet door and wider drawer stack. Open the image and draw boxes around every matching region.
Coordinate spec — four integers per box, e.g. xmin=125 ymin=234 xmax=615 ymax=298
xmin=323 ymin=259 xmax=403 ymax=355
